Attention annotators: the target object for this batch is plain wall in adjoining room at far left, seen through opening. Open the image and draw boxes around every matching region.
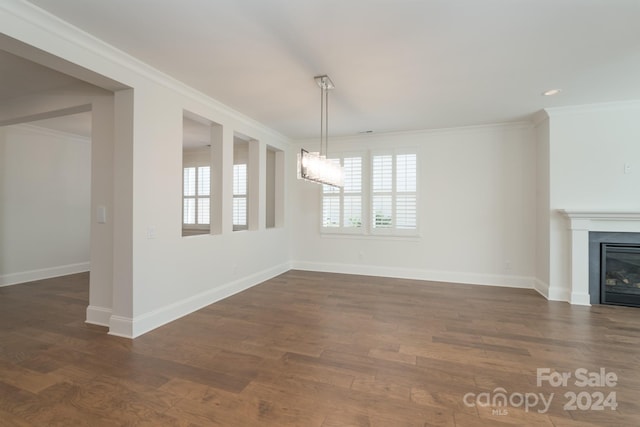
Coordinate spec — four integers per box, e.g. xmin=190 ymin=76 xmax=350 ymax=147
xmin=0 ymin=125 xmax=91 ymax=285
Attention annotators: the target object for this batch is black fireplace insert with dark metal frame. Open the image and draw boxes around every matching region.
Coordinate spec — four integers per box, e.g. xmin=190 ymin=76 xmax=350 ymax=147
xmin=600 ymin=243 xmax=640 ymax=307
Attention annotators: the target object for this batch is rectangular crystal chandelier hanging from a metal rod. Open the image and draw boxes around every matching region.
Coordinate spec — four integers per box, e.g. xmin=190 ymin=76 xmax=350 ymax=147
xmin=298 ymin=75 xmax=344 ymax=187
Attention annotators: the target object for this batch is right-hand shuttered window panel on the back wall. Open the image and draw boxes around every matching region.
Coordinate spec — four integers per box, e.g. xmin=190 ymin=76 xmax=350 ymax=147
xmin=371 ymin=153 xmax=418 ymax=231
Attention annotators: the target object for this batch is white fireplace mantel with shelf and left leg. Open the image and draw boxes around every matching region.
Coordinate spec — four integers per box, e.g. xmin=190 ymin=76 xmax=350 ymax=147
xmin=559 ymin=209 xmax=640 ymax=305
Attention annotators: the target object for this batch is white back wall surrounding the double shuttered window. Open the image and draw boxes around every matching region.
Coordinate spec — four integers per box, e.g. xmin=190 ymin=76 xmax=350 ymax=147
xmin=289 ymin=124 xmax=536 ymax=287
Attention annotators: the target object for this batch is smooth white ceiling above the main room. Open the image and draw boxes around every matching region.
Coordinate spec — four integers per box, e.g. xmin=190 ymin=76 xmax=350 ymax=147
xmin=10 ymin=0 xmax=640 ymax=138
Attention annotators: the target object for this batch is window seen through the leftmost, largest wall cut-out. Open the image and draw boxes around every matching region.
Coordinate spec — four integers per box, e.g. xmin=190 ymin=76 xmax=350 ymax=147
xmin=182 ymin=166 xmax=211 ymax=225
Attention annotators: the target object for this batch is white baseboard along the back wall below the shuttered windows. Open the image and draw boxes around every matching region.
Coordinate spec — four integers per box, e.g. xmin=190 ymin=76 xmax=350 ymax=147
xmin=291 ymin=261 xmax=535 ymax=289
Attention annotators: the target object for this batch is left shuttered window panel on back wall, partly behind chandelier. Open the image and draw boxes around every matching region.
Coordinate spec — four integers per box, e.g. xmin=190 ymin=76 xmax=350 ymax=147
xmin=322 ymin=157 xmax=362 ymax=229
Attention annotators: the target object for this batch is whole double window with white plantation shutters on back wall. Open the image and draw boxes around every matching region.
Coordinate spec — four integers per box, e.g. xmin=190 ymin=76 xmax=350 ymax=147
xmin=322 ymin=151 xmax=418 ymax=235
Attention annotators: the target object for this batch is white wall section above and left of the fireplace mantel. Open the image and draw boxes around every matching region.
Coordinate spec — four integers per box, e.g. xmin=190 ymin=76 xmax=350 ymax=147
xmin=548 ymin=102 xmax=640 ymax=301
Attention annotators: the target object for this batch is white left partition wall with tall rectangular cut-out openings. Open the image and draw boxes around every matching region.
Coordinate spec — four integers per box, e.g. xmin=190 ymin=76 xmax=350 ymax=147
xmin=127 ymin=81 xmax=289 ymax=336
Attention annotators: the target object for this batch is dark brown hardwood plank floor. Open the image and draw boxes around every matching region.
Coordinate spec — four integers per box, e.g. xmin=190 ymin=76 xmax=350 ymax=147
xmin=0 ymin=271 xmax=640 ymax=427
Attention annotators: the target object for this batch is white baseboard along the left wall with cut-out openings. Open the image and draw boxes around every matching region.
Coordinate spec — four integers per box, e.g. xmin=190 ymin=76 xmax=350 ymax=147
xmin=109 ymin=263 xmax=291 ymax=338
